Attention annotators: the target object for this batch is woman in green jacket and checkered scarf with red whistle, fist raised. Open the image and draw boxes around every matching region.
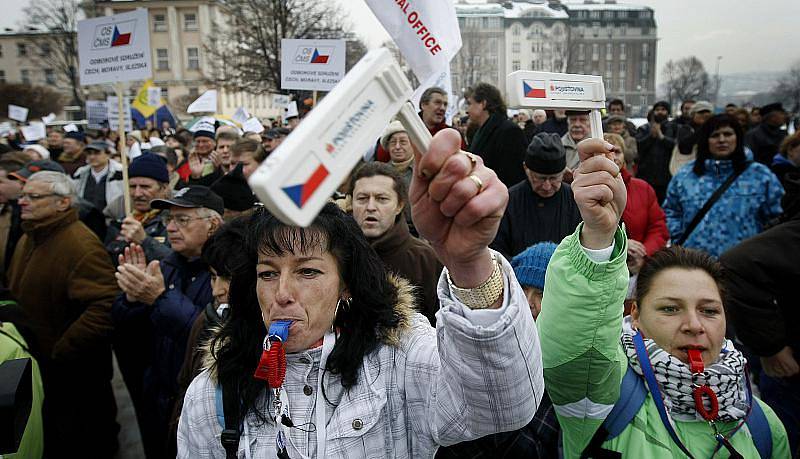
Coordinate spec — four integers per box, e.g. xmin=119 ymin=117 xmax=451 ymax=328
xmin=537 ymin=139 xmax=790 ymax=459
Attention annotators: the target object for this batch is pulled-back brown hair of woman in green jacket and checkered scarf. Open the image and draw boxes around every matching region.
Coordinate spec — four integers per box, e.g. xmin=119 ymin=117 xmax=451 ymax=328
xmin=636 ymin=245 xmax=725 ymax=304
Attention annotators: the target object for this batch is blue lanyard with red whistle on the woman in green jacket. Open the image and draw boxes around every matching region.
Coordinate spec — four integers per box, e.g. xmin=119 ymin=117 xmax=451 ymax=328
xmin=633 ymin=332 xmax=752 ymax=459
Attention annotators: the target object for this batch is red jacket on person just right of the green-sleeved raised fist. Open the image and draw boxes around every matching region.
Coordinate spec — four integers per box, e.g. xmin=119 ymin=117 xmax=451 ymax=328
xmin=622 ymin=169 xmax=669 ymax=257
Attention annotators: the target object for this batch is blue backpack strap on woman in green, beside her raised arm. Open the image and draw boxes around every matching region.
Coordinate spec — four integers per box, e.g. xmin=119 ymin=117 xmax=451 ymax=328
xmin=581 ymin=365 xmax=647 ymax=458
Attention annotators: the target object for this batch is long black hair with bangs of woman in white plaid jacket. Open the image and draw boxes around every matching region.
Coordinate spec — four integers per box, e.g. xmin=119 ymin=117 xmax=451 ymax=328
xmin=211 ymin=203 xmax=401 ymax=421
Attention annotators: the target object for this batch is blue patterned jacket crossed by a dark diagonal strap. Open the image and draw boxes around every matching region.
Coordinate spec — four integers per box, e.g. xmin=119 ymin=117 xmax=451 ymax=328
xmin=662 ymin=159 xmax=784 ymax=257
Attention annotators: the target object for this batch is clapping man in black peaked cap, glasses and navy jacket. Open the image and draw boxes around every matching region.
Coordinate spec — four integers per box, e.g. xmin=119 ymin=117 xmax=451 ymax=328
xmin=111 ymin=185 xmax=224 ymax=457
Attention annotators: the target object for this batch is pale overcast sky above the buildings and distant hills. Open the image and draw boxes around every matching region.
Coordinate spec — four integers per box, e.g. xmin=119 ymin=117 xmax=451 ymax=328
xmin=0 ymin=0 xmax=800 ymax=82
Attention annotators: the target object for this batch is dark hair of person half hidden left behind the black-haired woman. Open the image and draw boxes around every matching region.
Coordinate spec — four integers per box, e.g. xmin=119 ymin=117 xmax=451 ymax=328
xmin=200 ymin=217 xmax=248 ymax=279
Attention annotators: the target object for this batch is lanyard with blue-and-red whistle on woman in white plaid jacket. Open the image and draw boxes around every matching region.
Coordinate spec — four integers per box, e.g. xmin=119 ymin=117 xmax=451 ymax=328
xmin=255 ymin=321 xmax=336 ymax=459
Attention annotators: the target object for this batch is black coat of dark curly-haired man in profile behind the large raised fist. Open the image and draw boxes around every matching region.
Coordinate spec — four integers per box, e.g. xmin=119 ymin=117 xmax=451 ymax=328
xmin=469 ymin=113 xmax=528 ymax=187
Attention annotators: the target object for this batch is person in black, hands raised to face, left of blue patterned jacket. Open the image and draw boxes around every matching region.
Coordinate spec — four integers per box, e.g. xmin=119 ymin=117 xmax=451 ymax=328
xmin=636 ymin=100 xmax=677 ymax=202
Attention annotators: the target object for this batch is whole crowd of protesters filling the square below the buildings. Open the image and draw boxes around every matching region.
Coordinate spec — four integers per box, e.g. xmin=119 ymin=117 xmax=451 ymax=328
xmin=0 ymin=83 xmax=800 ymax=459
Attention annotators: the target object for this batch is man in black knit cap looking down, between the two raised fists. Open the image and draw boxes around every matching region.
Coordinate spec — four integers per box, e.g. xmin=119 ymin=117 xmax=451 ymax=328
xmin=491 ymin=132 xmax=581 ymax=260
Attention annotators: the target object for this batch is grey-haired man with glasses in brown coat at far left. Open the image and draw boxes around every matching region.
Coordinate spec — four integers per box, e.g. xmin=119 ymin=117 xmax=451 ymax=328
xmin=8 ymin=171 xmax=119 ymax=457
